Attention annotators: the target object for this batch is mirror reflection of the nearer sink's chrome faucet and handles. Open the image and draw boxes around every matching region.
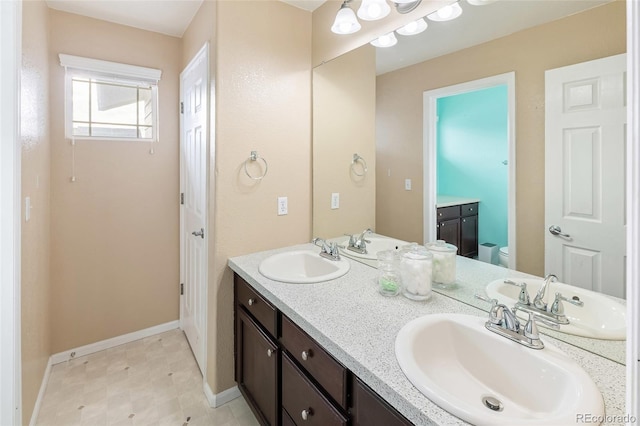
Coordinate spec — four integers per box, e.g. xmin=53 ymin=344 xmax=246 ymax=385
xmin=504 ymin=274 xmax=584 ymax=324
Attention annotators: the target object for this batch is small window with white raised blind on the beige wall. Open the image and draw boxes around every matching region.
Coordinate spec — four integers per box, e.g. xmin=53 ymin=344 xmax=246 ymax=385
xmin=60 ymin=54 xmax=160 ymax=142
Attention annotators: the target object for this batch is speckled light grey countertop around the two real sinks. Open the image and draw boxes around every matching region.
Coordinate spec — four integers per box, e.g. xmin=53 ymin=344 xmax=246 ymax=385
xmin=229 ymin=244 xmax=625 ymax=425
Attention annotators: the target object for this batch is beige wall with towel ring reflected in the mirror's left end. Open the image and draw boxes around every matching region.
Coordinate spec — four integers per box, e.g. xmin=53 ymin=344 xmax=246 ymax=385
xmin=313 ymin=43 xmax=376 ymax=238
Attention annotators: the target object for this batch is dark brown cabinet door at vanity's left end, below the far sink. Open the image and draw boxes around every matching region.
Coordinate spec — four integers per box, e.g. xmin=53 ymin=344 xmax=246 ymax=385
xmin=236 ymin=307 xmax=280 ymax=426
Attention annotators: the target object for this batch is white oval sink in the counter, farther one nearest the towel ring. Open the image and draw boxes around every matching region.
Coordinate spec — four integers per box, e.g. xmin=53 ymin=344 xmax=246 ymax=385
xmin=258 ymin=250 xmax=351 ymax=284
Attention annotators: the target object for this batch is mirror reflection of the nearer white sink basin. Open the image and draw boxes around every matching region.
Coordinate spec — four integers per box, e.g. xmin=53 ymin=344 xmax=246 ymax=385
xmin=486 ymin=279 xmax=627 ymax=340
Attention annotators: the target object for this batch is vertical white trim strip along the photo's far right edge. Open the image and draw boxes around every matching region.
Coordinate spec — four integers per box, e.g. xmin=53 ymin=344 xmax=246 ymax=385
xmin=625 ymin=1 xmax=640 ymax=418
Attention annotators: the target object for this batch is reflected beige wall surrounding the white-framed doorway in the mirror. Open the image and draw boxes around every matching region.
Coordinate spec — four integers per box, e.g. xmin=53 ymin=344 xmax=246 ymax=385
xmin=376 ymin=1 xmax=626 ymax=275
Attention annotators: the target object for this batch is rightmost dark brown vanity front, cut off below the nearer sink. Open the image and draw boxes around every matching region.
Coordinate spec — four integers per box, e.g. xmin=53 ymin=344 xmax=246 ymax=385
xmin=351 ymin=377 xmax=412 ymax=426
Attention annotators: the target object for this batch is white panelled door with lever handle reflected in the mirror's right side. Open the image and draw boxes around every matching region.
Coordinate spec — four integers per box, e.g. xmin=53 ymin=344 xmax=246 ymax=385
xmin=545 ymin=54 xmax=626 ymax=297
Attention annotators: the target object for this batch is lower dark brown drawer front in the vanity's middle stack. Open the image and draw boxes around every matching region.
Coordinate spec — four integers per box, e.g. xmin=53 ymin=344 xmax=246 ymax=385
xmin=282 ymin=352 xmax=347 ymax=426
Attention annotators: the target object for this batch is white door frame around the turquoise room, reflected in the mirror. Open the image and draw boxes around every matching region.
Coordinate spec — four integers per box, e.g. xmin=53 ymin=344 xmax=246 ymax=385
xmin=423 ymin=72 xmax=517 ymax=269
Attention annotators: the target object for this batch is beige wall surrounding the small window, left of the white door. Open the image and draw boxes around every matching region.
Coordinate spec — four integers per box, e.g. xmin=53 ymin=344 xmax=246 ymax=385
xmin=49 ymin=10 xmax=182 ymax=353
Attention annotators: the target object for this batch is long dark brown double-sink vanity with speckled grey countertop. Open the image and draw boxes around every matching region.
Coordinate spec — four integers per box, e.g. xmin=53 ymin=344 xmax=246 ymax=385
xmin=229 ymin=244 xmax=625 ymax=425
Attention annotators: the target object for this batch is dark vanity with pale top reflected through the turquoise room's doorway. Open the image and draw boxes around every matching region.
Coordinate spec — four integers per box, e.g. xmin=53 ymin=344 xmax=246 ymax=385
xmin=436 ymin=195 xmax=480 ymax=258
